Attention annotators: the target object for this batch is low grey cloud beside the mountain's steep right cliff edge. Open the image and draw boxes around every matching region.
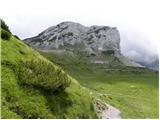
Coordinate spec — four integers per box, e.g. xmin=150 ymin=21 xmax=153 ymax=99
xmin=121 ymin=30 xmax=159 ymax=64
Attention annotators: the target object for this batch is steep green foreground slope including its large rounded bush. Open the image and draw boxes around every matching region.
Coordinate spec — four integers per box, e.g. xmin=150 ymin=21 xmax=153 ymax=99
xmin=1 ymin=30 xmax=97 ymax=119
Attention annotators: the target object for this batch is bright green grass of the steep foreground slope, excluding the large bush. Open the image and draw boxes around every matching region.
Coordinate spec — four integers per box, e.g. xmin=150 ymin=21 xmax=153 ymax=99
xmin=1 ymin=33 xmax=97 ymax=118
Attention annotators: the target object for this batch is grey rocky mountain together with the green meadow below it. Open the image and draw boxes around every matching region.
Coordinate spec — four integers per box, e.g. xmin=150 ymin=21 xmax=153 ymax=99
xmin=24 ymin=22 xmax=159 ymax=118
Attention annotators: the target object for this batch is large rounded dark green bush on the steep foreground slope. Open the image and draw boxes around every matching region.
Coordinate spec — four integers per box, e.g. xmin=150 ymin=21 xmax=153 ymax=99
xmin=17 ymin=60 xmax=70 ymax=92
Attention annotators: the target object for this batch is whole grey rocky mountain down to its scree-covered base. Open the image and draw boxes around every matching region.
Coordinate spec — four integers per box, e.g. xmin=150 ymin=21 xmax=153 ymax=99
xmin=24 ymin=22 xmax=142 ymax=67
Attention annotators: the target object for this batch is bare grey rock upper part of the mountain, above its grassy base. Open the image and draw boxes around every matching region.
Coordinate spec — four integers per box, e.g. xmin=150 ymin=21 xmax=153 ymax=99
xmin=25 ymin=22 xmax=120 ymax=52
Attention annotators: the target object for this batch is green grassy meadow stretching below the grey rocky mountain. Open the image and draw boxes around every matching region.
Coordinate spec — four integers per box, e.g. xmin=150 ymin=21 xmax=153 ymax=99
xmin=41 ymin=52 xmax=159 ymax=118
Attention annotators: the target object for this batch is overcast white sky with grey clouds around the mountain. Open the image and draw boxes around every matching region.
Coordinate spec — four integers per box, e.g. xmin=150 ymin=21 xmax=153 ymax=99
xmin=0 ymin=0 xmax=160 ymax=62
